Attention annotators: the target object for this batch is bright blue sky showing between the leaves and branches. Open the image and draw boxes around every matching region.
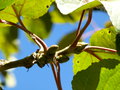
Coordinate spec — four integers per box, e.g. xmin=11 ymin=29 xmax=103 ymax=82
xmin=2 ymin=12 xmax=109 ymax=90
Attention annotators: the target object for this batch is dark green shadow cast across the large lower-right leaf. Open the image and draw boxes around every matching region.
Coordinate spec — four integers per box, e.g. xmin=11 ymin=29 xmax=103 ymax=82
xmin=72 ymin=59 xmax=120 ymax=90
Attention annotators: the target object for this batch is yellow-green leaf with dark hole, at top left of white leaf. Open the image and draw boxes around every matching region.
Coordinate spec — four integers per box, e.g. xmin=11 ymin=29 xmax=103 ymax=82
xmin=15 ymin=0 xmax=54 ymax=19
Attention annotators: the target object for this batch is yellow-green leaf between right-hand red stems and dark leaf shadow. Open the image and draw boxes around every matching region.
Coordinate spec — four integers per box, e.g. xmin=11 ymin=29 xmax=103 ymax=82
xmin=73 ymin=51 xmax=120 ymax=74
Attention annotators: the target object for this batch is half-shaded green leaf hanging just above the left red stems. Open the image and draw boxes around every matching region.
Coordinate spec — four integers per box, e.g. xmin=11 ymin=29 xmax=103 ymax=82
xmin=23 ymin=13 xmax=52 ymax=38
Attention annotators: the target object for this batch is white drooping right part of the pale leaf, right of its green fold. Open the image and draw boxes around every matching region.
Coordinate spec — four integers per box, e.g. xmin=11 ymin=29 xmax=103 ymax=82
xmin=101 ymin=0 xmax=120 ymax=31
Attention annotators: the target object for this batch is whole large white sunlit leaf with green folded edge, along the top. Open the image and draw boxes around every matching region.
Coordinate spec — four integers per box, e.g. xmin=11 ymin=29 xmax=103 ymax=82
xmin=56 ymin=0 xmax=120 ymax=30
